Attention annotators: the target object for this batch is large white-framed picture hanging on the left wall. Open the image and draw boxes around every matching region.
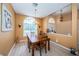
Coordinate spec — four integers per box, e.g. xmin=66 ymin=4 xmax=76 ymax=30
xmin=1 ymin=4 xmax=12 ymax=31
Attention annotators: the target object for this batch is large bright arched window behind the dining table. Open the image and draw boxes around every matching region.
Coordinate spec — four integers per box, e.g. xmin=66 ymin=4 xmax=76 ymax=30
xmin=23 ymin=17 xmax=37 ymax=36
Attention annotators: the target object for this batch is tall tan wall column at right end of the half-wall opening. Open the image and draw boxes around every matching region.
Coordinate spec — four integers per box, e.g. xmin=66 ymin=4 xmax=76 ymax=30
xmin=72 ymin=3 xmax=78 ymax=49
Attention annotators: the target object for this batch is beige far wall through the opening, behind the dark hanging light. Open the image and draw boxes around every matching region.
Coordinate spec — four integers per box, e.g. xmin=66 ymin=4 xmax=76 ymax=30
xmin=55 ymin=13 xmax=72 ymax=35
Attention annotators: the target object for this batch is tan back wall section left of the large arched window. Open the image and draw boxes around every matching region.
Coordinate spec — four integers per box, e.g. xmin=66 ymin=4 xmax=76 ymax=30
xmin=16 ymin=14 xmax=26 ymax=39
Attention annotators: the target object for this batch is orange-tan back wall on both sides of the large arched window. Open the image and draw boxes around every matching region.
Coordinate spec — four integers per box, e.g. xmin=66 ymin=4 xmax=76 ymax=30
xmin=16 ymin=14 xmax=42 ymax=40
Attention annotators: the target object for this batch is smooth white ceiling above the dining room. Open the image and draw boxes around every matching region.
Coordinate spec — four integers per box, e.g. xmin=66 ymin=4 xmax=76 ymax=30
xmin=12 ymin=3 xmax=68 ymax=18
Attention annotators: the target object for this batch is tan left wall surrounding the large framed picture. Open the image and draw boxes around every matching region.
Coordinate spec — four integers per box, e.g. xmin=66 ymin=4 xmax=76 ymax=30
xmin=0 ymin=3 xmax=15 ymax=55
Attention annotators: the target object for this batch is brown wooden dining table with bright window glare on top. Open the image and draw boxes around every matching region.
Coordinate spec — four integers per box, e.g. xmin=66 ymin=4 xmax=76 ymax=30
xmin=29 ymin=35 xmax=50 ymax=56
